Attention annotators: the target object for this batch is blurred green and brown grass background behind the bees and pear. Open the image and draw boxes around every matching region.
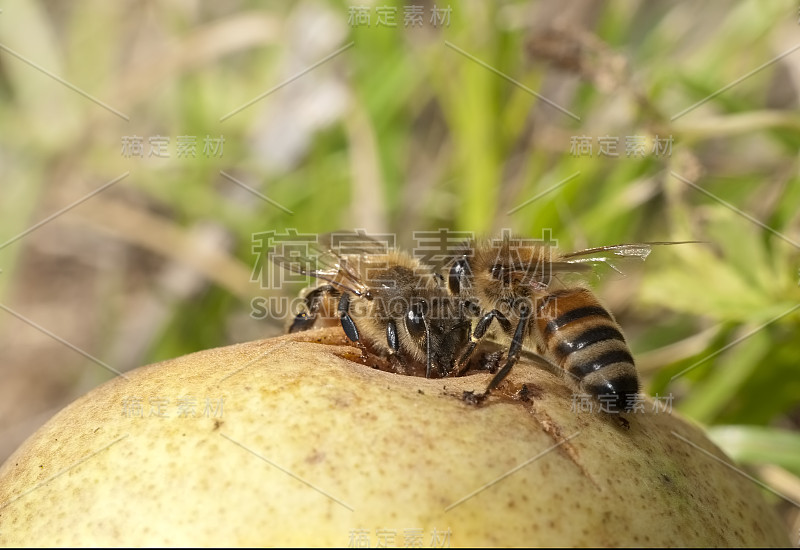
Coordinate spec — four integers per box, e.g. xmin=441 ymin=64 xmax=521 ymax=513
xmin=0 ymin=0 xmax=800 ymax=542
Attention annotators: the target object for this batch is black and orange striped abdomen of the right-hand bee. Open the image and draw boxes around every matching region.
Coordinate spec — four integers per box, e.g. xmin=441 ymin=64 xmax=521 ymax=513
xmin=534 ymin=288 xmax=639 ymax=411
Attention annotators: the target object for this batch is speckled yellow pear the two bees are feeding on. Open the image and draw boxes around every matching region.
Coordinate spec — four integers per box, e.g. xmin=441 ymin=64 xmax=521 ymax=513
xmin=0 ymin=329 xmax=789 ymax=546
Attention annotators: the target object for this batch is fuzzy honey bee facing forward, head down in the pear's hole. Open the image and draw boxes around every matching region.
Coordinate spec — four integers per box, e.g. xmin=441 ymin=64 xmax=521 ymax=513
xmin=283 ymin=246 xmax=472 ymax=378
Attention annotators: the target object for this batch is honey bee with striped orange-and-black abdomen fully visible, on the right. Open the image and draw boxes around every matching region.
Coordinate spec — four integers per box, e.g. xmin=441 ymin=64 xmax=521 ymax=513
xmin=447 ymin=234 xmax=697 ymax=412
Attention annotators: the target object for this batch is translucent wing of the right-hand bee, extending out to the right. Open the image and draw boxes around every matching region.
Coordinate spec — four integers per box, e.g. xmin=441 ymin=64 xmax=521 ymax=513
xmin=552 ymin=241 xmax=705 ymax=277
